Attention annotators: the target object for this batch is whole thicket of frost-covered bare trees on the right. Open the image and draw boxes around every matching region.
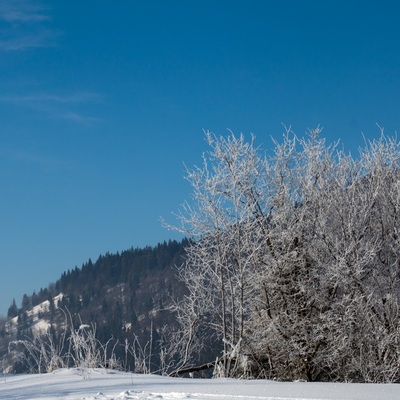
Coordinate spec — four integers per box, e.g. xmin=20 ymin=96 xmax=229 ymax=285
xmin=168 ymin=129 xmax=400 ymax=382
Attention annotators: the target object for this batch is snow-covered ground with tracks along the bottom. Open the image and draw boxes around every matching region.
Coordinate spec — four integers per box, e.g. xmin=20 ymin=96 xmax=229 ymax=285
xmin=0 ymin=369 xmax=400 ymax=400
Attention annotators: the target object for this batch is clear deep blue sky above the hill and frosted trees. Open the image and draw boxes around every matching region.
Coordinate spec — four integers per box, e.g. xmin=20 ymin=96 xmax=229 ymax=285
xmin=0 ymin=0 xmax=400 ymax=314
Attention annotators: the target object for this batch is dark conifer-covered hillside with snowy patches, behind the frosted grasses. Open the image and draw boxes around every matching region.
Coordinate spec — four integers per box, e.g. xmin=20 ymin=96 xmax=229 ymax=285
xmin=0 ymin=240 xmax=194 ymax=372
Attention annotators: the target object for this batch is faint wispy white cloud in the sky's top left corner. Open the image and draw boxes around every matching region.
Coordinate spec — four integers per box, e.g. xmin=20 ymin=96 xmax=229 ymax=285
xmin=0 ymin=0 xmax=59 ymax=51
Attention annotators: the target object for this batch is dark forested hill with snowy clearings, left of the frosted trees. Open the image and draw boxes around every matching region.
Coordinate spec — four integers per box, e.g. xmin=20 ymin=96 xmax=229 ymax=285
xmin=0 ymin=239 xmax=188 ymax=374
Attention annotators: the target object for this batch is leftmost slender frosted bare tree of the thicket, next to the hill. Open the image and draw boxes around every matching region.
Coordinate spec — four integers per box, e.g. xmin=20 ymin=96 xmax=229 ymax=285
xmin=164 ymin=132 xmax=265 ymax=375
